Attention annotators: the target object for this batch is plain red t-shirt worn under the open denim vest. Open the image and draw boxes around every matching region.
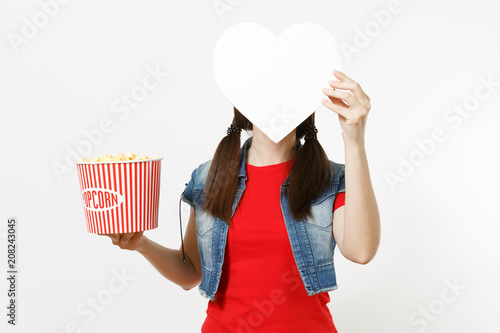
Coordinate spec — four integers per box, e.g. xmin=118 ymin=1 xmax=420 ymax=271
xmin=201 ymin=159 xmax=344 ymax=333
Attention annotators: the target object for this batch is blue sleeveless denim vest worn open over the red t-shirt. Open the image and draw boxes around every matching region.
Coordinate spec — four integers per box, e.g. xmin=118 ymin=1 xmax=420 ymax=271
xmin=180 ymin=137 xmax=345 ymax=301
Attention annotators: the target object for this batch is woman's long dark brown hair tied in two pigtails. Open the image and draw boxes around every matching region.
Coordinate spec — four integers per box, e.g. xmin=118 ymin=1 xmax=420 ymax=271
xmin=203 ymin=107 xmax=332 ymax=226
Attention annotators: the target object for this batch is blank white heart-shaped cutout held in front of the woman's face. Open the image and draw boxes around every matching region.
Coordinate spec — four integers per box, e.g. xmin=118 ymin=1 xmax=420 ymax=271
xmin=213 ymin=22 xmax=341 ymax=143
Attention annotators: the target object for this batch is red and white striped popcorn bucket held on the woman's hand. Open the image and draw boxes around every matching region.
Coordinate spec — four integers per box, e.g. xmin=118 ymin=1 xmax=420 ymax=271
xmin=76 ymin=158 xmax=163 ymax=234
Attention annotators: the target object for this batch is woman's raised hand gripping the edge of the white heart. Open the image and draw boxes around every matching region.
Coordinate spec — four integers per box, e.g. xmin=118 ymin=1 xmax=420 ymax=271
xmin=322 ymin=71 xmax=371 ymax=144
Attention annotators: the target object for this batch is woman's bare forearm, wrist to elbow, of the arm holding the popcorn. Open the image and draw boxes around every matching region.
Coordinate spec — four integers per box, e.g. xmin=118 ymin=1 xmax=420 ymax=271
xmin=137 ymin=237 xmax=199 ymax=290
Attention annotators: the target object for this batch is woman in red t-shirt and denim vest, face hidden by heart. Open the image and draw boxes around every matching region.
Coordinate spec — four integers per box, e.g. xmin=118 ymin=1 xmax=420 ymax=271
xmin=103 ymin=71 xmax=380 ymax=333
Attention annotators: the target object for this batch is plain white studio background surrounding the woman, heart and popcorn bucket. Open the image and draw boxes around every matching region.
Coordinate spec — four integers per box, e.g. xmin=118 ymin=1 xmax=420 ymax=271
xmin=0 ymin=0 xmax=500 ymax=333
